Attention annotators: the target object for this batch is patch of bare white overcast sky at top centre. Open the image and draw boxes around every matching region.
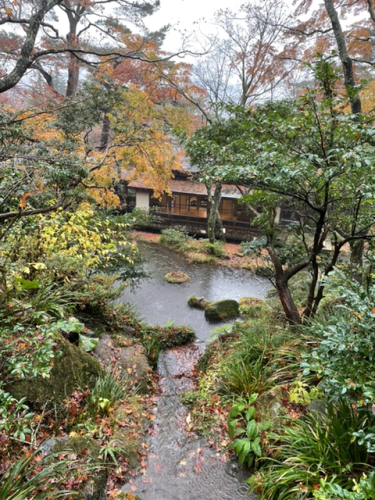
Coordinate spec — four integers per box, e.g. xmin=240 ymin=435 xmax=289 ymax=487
xmin=145 ymin=0 xmax=244 ymax=52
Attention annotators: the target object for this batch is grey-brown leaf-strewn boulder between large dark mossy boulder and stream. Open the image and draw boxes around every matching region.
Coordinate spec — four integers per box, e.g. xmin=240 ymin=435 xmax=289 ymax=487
xmin=93 ymin=335 xmax=151 ymax=393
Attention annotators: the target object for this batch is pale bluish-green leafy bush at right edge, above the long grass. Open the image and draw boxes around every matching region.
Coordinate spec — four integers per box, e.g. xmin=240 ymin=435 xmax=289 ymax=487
xmin=301 ymin=272 xmax=375 ymax=403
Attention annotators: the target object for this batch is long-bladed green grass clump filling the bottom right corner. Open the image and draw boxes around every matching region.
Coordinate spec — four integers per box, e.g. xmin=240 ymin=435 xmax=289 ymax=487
xmin=248 ymin=400 xmax=375 ymax=500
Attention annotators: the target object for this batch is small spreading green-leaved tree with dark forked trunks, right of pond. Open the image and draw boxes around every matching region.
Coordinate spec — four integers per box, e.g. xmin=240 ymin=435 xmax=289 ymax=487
xmin=191 ymin=59 xmax=375 ymax=323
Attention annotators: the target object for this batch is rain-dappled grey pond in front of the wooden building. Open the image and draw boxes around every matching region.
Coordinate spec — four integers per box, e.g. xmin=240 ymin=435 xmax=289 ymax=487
xmin=120 ymin=243 xmax=270 ymax=341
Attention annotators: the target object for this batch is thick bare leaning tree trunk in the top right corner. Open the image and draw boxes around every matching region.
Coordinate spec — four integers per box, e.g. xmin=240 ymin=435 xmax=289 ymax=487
xmin=324 ymin=0 xmax=362 ymax=114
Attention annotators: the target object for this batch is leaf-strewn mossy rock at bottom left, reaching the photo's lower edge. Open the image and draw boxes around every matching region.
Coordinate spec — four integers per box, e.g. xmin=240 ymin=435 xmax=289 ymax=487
xmin=42 ymin=436 xmax=107 ymax=500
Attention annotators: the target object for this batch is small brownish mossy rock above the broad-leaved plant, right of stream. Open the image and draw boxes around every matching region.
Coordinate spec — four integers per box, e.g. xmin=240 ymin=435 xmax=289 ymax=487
xmin=256 ymin=386 xmax=288 ymax=431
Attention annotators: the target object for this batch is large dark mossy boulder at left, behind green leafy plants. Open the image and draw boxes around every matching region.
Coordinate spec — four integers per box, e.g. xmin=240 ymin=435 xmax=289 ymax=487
xmin=6 ymin=336 xmax=103 ymax=409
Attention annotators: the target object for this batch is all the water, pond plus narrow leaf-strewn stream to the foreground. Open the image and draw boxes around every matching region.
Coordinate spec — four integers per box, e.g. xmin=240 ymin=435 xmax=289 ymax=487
xmin=121 ymin=241 xmax=269 ymax=500
